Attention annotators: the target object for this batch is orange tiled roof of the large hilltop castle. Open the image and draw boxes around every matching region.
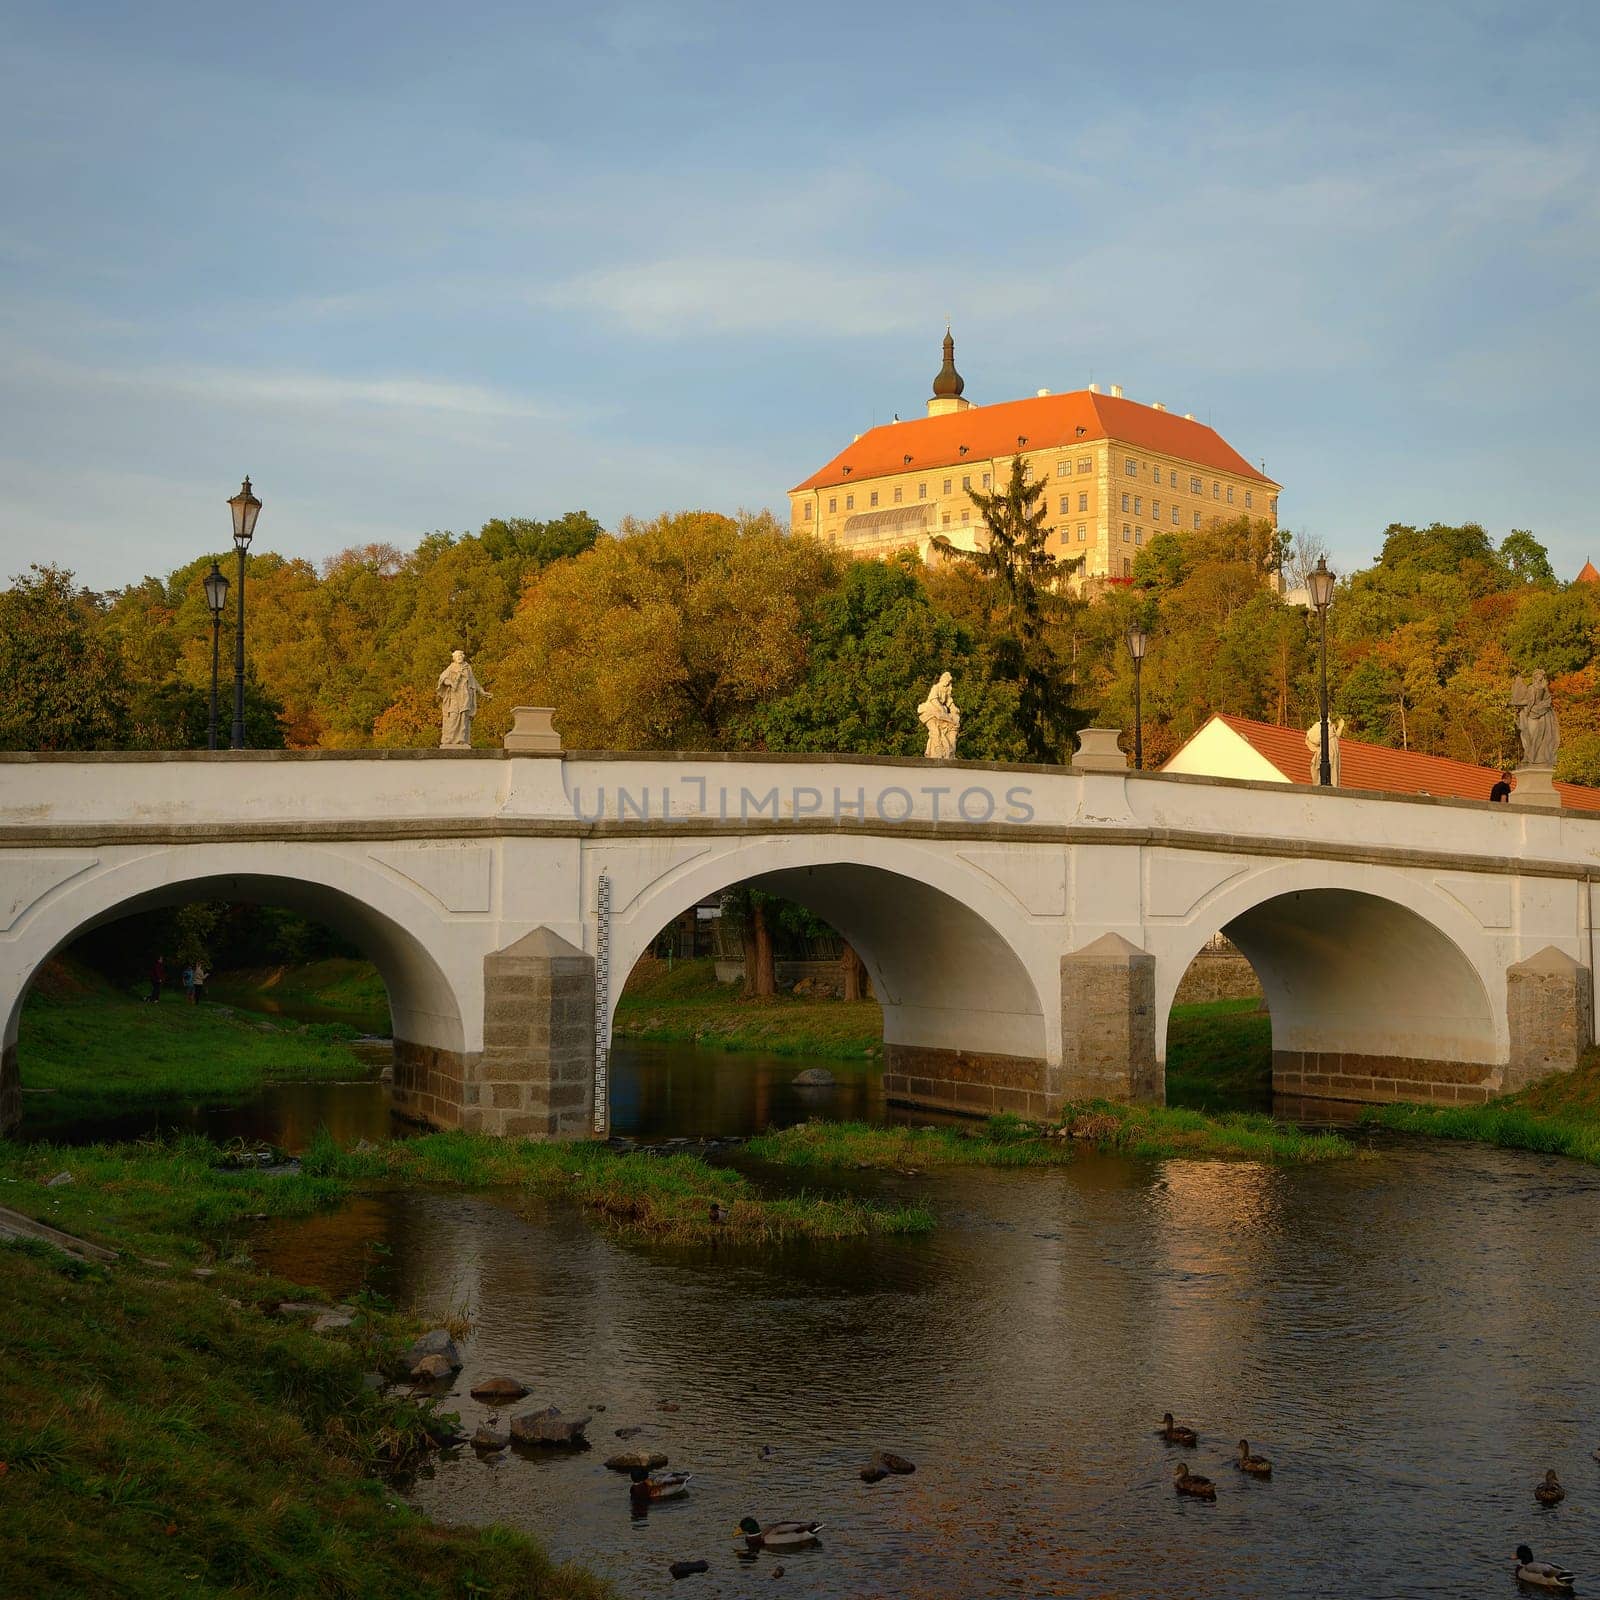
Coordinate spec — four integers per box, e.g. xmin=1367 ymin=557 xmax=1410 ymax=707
xmin=789 ymin=389 xmax=1278 ymax=494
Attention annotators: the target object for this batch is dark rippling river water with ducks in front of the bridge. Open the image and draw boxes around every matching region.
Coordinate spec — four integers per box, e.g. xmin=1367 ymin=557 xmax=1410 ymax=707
xmin=256 ymin=1144 xmax=1600 ymax=1600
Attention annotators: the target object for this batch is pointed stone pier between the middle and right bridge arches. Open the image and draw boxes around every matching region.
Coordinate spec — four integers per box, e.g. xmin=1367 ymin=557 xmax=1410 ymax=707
xmin=1059 ymin=933 xmax=1165 ymax=1104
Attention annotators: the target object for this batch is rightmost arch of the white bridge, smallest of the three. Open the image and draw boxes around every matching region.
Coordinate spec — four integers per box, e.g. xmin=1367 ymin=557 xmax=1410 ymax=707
xmin=1152 ymin=861 xmax=1507 ymax=1101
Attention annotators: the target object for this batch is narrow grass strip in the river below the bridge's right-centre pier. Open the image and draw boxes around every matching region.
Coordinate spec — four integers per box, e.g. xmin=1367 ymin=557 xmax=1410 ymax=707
xmin=744 ymin=1101 xmax=1360 ymax=1171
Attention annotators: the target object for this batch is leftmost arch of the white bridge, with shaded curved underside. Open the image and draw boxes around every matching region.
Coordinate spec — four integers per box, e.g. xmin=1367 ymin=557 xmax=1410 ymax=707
xmin=0 ymin=843 xmax=483 ymax=1126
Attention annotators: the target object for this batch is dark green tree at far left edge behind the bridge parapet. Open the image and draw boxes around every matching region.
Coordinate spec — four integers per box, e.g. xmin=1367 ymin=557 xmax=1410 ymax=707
xmin=0 ymin=563 xmax=128 ymax=750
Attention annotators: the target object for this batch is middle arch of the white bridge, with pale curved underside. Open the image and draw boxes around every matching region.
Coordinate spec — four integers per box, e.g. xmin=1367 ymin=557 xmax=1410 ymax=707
xmin=606 ymin=835 xmax=1061 ymax=1115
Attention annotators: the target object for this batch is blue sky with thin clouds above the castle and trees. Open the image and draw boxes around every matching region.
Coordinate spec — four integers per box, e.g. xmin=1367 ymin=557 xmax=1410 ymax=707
xmin=0 ymin=0 xmax=1600 ymax=587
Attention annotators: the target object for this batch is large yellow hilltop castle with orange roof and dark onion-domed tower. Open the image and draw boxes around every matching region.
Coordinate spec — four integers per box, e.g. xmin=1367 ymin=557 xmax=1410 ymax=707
xmin=789 ymin=331 xmax=1278 ymax=579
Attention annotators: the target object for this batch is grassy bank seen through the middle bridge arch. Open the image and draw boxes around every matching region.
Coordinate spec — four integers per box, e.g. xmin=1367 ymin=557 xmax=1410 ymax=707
xmin=613 ymin=960 xmax=883 ymax=1061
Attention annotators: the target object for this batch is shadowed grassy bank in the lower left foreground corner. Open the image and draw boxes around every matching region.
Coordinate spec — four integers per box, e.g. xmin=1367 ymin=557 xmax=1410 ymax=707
xmin=0 ymin=1139 xmax=633 ymax=1600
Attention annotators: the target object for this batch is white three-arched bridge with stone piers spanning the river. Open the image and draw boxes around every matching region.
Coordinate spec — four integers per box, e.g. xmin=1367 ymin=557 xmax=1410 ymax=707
xmin=0 ymin=750 xmax=1600 ymax=1138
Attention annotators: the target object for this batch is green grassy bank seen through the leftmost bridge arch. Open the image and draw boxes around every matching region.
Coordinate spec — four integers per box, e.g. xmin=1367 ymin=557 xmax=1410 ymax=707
xmin=18 ymin=963 xmax=368 ymax=1131
